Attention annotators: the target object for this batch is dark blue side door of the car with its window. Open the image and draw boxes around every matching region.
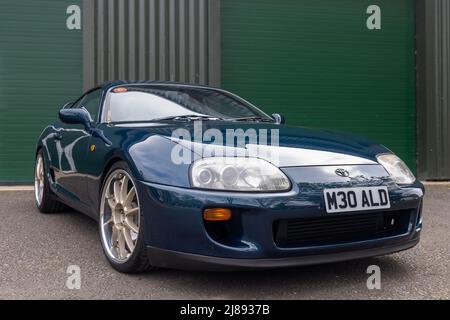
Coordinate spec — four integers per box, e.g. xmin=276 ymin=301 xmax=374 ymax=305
xmin=55 ymin=89 xmax=102 ymax=205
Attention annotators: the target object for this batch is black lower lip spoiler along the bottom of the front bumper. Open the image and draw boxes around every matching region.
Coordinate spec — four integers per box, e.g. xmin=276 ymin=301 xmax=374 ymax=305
xmin=147 ymin=237 xmax=420 ymax=271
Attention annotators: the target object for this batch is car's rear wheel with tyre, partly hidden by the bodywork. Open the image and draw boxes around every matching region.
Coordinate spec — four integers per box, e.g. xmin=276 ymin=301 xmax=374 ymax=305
xmin=34 ymin=150 xmax=68 ymax=213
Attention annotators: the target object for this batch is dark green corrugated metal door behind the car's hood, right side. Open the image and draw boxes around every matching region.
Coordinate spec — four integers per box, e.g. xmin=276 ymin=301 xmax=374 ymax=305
xmin=221 ymin=0 xmax=416 ymax=169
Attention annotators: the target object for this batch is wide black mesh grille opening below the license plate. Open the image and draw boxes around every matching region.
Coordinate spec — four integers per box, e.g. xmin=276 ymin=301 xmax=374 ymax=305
xmin=274 ymin=210 xmax=411 ymax=246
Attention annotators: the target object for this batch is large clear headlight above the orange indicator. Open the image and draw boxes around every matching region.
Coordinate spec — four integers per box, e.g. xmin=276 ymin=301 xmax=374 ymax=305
xmin=190 ymin=157 xmax=291 ymax=192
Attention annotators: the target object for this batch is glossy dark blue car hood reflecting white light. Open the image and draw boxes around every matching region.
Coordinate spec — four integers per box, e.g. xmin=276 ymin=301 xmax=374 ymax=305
xmin=114 ymin=121 xmax=390 ymax=167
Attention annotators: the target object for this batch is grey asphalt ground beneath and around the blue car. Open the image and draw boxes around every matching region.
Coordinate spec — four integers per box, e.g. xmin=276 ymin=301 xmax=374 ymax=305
xmin=0 ymin=185 xmax=450 ymax=299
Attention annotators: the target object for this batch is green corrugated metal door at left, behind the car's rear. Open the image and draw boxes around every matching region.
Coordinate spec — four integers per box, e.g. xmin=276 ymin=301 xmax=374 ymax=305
xmin=0 ymin=0 xmax=82 ymax=183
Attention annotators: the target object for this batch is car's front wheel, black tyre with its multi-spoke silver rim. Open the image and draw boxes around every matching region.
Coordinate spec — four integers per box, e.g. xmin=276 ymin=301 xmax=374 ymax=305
xmin=98 ymin=161 xmax=155 ymax=273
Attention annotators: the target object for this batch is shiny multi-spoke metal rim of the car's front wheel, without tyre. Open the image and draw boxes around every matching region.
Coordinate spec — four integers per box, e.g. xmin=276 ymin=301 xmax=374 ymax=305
xmin=100 ymin=169 xmax=140 ymax=263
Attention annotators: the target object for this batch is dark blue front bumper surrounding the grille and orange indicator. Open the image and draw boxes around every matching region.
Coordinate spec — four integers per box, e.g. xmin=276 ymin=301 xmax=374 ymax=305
xmin=138 ymin=166 xmax=424 ymax=271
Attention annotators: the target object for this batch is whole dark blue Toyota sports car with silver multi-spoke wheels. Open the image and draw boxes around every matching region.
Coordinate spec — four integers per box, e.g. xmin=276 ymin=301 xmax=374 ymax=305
xmin=35 ymin=81 xmax=424 ymax=272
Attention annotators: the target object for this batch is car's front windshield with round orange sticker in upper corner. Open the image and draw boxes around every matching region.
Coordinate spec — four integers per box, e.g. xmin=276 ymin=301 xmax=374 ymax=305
xmin=104 ymin=85 xmax=272 ymax=122
